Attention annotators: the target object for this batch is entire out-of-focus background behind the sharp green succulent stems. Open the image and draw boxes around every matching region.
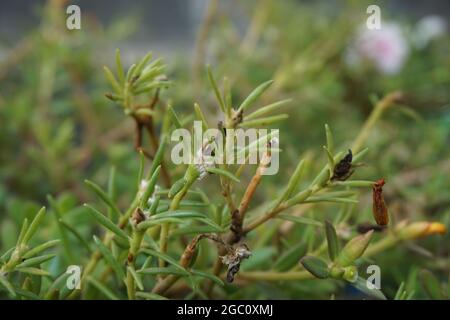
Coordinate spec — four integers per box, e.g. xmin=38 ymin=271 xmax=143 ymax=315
xmin=0 ymin=0 xmax=450 ymax=298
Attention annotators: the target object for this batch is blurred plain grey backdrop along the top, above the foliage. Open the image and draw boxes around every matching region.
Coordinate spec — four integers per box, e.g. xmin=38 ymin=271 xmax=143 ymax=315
xmin=0 ymin=0 xmax=450 ymax=59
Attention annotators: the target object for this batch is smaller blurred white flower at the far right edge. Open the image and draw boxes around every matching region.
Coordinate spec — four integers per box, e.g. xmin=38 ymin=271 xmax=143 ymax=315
xmin=413 ymin=15 xmax=447 ymax=49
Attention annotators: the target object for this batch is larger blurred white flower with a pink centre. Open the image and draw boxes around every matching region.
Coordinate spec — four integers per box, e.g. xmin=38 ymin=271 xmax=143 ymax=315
xmin=346 ymin=23 xmax=409 ymax=74
